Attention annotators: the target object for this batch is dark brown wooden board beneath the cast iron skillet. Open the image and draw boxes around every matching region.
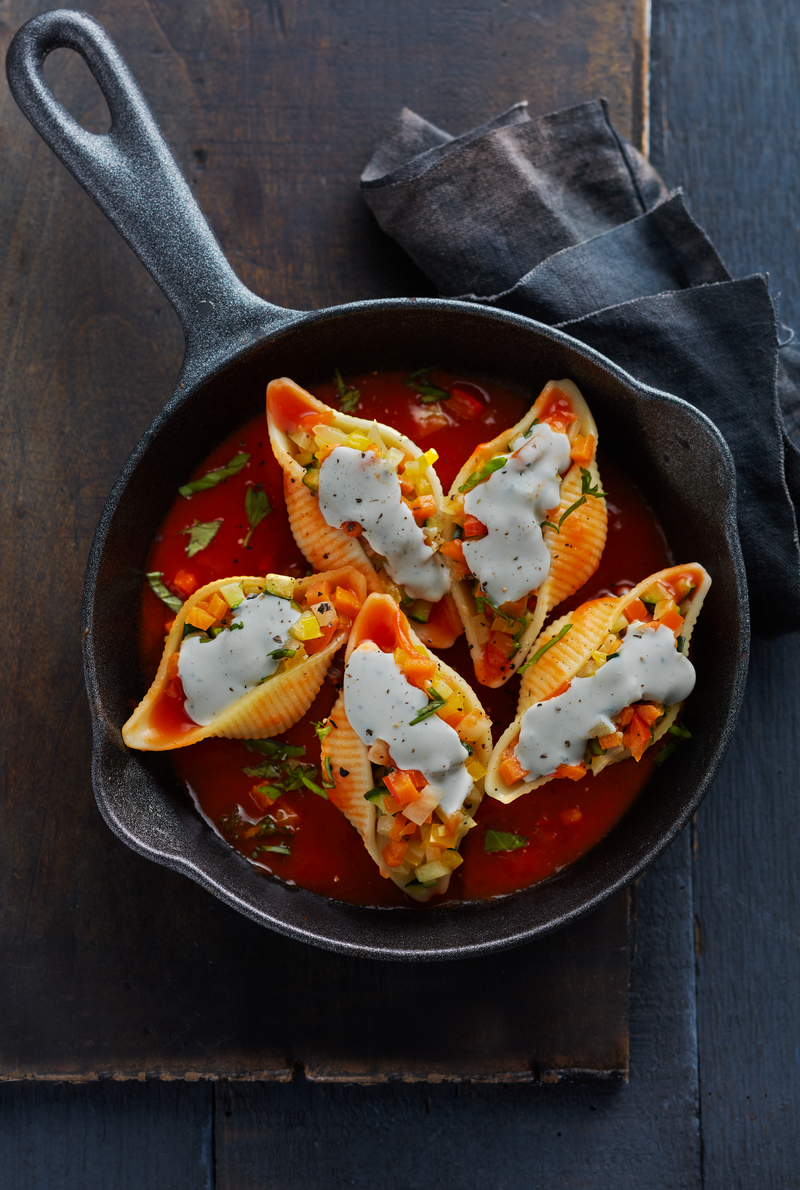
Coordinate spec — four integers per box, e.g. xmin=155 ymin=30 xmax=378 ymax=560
xmin=0 ymin=0 xmax=635 ymax=1081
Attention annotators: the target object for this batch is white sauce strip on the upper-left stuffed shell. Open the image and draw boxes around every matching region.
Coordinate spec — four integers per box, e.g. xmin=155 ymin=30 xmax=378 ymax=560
xmin=319 ymin=446 xmax=450 ymax=603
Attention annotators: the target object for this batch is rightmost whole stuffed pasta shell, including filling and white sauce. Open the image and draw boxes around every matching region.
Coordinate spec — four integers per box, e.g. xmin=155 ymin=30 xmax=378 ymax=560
xmin=486 ymin=563 xmax=711 ymax=802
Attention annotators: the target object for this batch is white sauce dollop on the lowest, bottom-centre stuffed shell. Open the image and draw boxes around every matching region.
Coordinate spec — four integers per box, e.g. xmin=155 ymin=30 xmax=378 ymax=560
xmin=344 ymin=641 xmax=473 ymax=814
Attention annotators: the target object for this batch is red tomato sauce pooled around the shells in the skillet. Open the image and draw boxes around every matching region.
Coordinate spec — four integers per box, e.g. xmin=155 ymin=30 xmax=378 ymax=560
xmin=139 ymin=369 xmax=670 ymax=907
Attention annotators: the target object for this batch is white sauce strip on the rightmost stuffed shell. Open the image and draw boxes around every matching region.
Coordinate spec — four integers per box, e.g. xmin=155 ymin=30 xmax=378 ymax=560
xmin=515 ymin=621 xmax=695 ymax=781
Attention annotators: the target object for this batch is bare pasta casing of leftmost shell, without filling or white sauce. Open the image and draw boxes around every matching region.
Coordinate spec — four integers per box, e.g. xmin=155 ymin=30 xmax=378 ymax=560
xmin=123 ymin=568 xmax=367 ymax=752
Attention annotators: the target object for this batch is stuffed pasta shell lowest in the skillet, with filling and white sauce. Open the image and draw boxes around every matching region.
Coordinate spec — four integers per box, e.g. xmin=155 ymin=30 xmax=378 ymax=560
xmin=321 ymin=594 xmax=492 ymax=901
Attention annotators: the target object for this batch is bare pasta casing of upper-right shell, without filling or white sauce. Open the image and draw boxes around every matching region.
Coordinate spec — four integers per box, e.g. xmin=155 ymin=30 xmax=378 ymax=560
xmin=444 ymin=380 xmax=608 ymax=688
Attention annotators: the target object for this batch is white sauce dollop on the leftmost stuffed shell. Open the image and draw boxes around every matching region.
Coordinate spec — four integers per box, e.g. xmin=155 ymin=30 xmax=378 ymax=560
xmin=177 ymin=595 xmax=301 ymax=727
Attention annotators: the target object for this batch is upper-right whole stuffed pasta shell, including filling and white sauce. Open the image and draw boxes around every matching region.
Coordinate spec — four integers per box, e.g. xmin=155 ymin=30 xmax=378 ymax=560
xmin=442 ymin=380 xmax=607 ymax=687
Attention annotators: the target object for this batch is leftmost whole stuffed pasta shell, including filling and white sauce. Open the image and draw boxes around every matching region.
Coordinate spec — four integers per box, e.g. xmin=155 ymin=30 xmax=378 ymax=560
xmin=123 ymin=568 xmax=367 ymax=752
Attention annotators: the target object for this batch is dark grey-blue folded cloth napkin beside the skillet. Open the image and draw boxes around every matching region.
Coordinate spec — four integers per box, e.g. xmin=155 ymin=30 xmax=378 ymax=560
xmin=361 ymin=100 xmax=800 ymax=637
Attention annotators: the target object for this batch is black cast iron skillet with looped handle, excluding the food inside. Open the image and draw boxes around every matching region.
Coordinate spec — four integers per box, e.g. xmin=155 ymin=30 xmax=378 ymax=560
xmin=7 ymin=11 xmax=749 ymax=959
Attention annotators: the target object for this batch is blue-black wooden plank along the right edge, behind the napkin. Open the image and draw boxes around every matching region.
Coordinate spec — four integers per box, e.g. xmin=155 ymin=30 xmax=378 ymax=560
xmin=654 ymin=0 xmax=800 ymax=1190
